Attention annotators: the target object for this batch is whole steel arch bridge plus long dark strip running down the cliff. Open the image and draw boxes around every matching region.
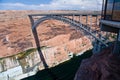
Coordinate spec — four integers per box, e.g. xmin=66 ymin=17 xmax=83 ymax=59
xmin=28 ymin=13 xmax=109 ymax=67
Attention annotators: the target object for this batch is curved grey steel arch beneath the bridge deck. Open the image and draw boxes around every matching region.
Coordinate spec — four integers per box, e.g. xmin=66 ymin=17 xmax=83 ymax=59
xmin=28 ymin=16 xmax=108 ymax=47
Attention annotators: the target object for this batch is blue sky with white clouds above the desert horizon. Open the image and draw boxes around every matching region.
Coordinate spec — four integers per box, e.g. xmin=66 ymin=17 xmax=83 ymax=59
xmin=0 ymin=0 xmax=102 ymax=11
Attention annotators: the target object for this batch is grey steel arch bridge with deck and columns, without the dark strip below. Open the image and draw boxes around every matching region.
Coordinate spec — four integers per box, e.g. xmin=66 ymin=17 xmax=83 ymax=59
xmin=29 ymin=13 xmax=109 ymax=53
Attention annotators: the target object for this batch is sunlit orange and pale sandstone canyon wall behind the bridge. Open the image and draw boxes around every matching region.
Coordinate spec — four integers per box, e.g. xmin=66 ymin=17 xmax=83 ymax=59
xmin=0 ymin=10 xmax=100 ymax=77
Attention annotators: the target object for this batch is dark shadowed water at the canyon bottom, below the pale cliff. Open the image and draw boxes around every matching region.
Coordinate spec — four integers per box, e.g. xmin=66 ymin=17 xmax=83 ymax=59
xmin=22 ymin=50 xmax=92 ymax=80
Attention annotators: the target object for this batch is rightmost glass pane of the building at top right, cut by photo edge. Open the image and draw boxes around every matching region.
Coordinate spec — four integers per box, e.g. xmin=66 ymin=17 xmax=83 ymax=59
xmin=113 ymin=0 xmax=120 ymax=21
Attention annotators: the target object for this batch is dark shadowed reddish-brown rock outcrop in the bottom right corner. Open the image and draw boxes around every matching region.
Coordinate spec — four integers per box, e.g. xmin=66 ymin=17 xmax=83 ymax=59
xmin=74 ymin=48 xmax=120 ymax=80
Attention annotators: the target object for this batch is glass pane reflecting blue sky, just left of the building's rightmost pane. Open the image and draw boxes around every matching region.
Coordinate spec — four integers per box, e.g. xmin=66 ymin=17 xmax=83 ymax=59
xmin=105 ymin=0 xmax=114 ymax=20
